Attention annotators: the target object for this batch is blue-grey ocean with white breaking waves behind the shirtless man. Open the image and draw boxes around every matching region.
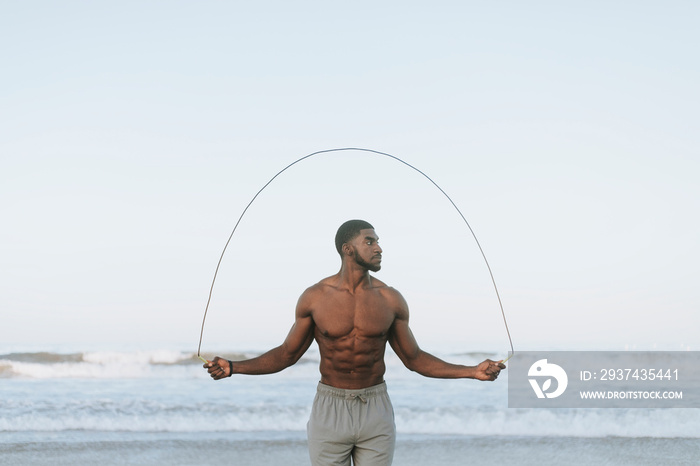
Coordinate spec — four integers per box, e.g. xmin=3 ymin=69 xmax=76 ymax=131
xmin=0 ymin=349 xmax=700 ymax=466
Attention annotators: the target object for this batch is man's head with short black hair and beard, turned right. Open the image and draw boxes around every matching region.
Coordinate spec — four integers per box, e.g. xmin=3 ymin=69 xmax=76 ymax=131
xmin=335 ymin=220 xmax=382 ymax=272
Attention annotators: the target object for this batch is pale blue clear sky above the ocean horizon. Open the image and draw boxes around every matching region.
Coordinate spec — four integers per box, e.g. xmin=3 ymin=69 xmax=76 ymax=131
xmin=0 ymin=1 xmax=700 ymax=353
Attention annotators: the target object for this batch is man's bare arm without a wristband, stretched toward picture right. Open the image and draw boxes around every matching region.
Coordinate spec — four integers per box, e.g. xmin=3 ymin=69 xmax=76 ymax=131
xmin=389 ymin=292 xmax=506 ymax=380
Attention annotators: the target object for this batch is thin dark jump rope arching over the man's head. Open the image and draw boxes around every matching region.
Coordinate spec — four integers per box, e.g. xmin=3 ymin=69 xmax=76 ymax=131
xmin=197 ymin=147 xmax=515 ymax=363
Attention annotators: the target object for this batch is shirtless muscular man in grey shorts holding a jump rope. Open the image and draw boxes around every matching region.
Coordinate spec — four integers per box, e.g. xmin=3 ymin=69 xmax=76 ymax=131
xmin=204 ymin=220 xmax=505 ymax=466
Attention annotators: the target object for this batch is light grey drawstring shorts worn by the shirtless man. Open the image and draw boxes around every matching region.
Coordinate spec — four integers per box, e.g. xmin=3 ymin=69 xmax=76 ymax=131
xmin=306 ymin=382 xmax=396 ymax=466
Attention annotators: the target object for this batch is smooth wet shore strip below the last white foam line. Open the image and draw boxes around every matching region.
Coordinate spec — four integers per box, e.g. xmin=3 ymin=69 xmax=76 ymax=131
xmin=0 ymin=432 xmax=700 ymax=466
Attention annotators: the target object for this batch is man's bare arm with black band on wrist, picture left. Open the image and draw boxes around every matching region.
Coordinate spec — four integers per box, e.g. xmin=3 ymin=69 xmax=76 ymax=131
xmin=204 ymin=291 xmax=314 ymax=380
